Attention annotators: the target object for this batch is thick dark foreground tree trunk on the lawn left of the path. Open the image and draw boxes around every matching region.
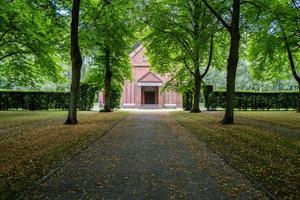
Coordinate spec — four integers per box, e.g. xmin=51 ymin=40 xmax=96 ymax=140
xmin=65 ymin=0 xmax=82 ymax=124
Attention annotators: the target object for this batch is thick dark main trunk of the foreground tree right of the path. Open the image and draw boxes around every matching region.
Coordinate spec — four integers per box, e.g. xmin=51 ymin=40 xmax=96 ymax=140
xmin=222 ymin=0 xmax=240 ymax=124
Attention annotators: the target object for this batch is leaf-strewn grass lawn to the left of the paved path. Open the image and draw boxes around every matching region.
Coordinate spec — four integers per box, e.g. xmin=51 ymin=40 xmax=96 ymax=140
xmin=0 ymin=111 xmax=128 ymax=199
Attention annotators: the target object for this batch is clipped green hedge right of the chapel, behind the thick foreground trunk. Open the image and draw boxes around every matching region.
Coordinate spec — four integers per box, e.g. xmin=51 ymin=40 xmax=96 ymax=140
xmin=204 ymin=86 xmax=298 ymax=110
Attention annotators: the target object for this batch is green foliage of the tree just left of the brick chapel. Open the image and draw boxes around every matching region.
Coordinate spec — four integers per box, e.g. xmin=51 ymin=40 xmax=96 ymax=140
xmin=81 ymin=1 xmax=136 ymax=89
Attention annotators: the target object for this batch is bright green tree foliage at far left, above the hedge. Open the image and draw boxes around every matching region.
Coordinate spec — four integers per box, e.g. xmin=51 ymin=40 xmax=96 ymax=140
xmin=0 ymin=0 xmax=64 ymax=87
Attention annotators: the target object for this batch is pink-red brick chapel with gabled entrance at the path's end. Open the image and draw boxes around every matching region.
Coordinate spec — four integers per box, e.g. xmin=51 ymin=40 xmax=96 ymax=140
xmin=100 ymin=45 xmax=182 ymax=108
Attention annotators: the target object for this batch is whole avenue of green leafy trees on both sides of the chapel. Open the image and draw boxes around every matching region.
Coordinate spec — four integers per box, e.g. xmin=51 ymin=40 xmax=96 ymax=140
xmin=0 ymin=0 xmax=300 ymax=124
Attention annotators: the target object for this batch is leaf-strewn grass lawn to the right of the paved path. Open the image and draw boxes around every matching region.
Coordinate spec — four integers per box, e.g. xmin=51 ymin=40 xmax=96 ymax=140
xmin=171 ymin=111 xmax=300 ymax=199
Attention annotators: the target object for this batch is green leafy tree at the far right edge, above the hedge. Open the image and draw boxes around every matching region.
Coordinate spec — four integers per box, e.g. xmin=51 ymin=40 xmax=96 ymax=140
xmin=249 ymin=0 xmax=300 ymax=112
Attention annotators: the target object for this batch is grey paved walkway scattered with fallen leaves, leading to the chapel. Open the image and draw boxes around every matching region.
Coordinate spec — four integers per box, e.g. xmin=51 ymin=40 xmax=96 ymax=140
xmin=28 ymin=112 xmax=263 ymax=200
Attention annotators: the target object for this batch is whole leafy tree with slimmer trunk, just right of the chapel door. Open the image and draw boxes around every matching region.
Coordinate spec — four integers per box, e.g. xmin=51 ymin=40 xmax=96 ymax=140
xmin=144 ymin=0 xmax=218 ymax=112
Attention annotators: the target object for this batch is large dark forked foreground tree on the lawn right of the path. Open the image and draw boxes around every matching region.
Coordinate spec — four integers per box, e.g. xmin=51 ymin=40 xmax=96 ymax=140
xmin=202 ymin=0 xmax=261 ymax=124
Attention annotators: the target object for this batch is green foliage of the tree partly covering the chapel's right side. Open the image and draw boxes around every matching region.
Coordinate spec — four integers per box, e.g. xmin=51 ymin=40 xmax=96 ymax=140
xmin=143 ymin=0 xmax=227 ymax=94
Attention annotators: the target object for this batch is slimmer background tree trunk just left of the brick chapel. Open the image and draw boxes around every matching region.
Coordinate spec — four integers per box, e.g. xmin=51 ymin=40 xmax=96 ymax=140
xmin=104 ymin=48 xmax=112 ymax=112
